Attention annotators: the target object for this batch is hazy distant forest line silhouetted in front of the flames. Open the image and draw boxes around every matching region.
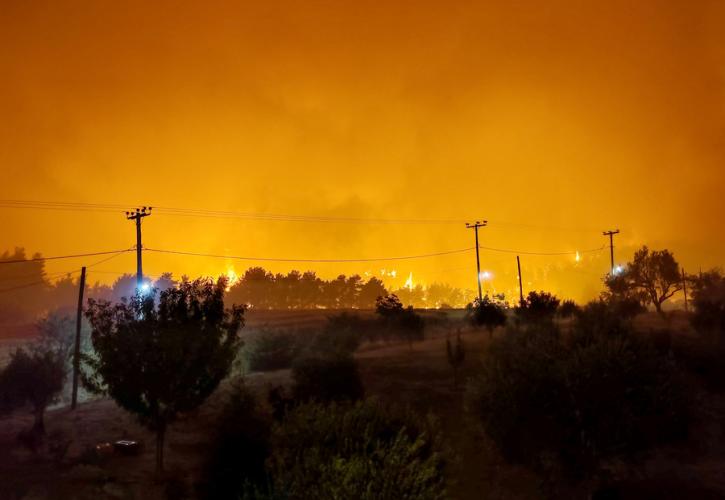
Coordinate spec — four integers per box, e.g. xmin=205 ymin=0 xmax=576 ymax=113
xmin=0 ymin=248 xmax=473 ymax=324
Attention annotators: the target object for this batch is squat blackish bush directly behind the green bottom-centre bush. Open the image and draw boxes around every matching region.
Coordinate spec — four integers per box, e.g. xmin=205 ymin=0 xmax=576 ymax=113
xmin=292 ymin=353 xmax=364 ymax=402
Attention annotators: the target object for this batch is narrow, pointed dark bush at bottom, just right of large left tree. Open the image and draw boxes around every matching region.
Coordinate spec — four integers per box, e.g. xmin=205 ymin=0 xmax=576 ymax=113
xmin=199 ymin=384 xmax=271 ymax=500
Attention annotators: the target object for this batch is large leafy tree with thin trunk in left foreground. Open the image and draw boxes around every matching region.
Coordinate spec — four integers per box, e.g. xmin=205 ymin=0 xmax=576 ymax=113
xmin=84 ymin=278 xmax=244 ymax=473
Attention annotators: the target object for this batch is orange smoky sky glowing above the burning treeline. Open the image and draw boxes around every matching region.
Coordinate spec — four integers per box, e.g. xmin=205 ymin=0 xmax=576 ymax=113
xmin=0 ymin=0 xmax=725 ymax=299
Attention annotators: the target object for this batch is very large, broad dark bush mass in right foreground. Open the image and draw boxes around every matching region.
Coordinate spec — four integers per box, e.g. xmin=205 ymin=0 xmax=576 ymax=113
xmin=469 ymin=311 xmax=688 ymax=484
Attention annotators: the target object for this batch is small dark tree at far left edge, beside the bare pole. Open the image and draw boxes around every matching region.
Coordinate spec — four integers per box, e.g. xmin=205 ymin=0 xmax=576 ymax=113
xmin=0 ymin=346 xmax=66 ymax=434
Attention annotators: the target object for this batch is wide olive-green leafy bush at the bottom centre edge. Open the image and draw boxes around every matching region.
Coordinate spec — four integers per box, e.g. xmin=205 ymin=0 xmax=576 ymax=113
xmin=268 ymin=400 xmax=445 ymax=500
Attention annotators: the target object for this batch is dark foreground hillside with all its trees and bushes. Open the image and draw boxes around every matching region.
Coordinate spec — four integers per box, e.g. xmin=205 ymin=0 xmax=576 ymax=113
xmin=0 ymin=245 xmax=725 ymax=499
